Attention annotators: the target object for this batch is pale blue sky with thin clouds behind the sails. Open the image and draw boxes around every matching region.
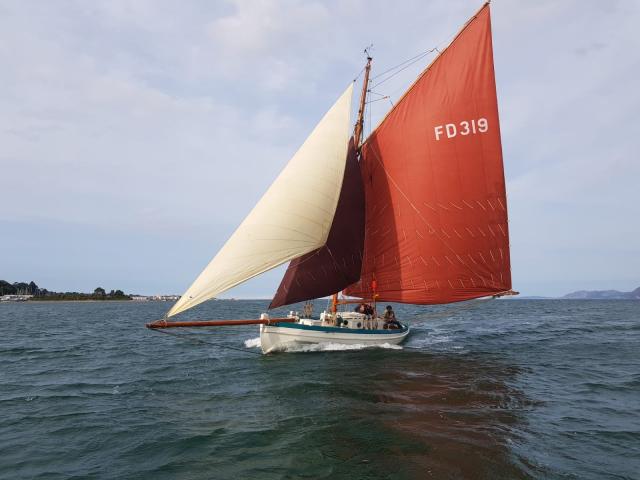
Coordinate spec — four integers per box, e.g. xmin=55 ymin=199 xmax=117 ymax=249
xmin=0 ymin=0 xmax=640 ymax=298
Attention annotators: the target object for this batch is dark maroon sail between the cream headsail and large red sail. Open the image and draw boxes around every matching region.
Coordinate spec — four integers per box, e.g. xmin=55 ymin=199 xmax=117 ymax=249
xmin=269 ymin=138 xmax=364 ymax=308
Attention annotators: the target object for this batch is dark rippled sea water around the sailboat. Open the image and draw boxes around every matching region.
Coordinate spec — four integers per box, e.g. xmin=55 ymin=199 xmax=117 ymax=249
xmin=0 ymin=300 xmax=640 ymax=480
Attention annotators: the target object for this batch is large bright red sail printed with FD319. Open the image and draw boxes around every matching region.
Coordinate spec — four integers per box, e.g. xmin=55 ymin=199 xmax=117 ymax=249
xmin=347 ymin=5 xmax=511 ymax=304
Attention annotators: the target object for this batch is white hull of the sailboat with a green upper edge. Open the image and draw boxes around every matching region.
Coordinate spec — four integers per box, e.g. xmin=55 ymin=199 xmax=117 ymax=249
xmin=260 ymin=324 xmax=410 ymax=353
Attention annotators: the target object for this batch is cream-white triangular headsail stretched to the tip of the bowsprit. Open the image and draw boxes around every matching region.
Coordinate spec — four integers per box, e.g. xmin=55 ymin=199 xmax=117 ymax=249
xmin=167 ymin=84 xmax=353 ymax=316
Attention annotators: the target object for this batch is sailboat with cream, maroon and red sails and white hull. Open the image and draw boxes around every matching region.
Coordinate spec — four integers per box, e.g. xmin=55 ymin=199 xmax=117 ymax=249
xmin=147 ymin=2 xmax=516 ymax=353
